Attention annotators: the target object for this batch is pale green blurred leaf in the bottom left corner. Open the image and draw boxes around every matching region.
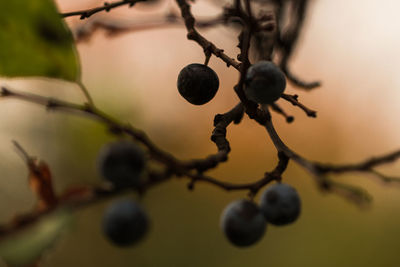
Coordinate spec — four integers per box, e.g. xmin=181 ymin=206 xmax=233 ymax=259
xmin=0 ymin=210 xmax=72 ymax=266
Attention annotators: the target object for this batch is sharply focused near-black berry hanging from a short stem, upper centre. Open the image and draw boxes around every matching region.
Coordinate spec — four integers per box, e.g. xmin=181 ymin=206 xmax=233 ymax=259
xmin=177 ymin=63 xmax=219 ymax=105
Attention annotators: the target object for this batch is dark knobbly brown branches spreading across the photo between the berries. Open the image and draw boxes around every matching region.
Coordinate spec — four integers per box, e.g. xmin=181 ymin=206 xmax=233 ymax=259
xmin=0 ymin=0 xmax=400 ymax=247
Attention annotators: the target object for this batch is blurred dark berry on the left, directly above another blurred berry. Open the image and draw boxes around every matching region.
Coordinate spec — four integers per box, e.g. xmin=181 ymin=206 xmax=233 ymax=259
xmin=98 ymin=140 xmax=146 ymax=188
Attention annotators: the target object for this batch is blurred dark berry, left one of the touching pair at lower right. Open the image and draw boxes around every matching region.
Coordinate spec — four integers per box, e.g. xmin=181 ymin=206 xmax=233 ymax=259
xmin=221 ymin=199 xmax=267 ymax=247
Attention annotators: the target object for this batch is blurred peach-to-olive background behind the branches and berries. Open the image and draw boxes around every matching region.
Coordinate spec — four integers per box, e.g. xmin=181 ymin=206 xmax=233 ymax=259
xmin=0 ymin=0 xmax=400 ymax=267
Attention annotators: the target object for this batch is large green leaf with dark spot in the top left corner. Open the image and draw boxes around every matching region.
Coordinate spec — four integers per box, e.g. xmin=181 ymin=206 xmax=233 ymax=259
xmin=0 ymin=0 xmax=80 ymax=81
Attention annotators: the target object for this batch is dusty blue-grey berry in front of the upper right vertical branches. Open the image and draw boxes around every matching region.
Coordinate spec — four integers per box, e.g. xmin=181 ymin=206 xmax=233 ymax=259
xmin=245 ymin=60 xmax=286 ymax=104
